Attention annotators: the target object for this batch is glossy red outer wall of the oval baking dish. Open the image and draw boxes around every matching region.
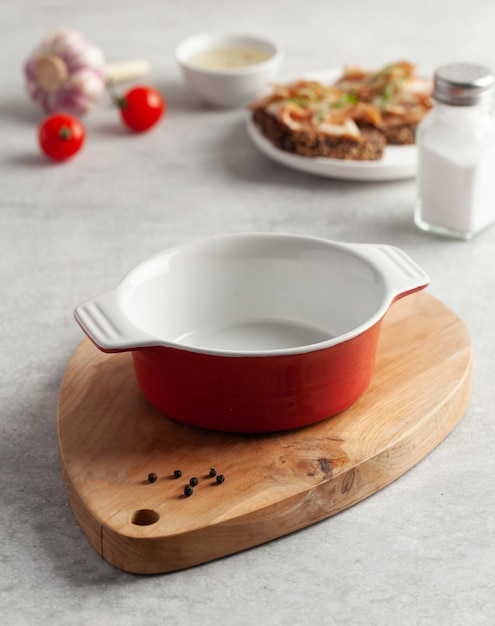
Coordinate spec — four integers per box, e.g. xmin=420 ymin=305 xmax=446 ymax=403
xmin=132 ymin=320 xmax=382 ymax=432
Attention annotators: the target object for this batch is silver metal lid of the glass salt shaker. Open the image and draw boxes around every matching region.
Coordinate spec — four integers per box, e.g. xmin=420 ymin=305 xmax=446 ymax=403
xmin=433 ymin=63 xmax=495 ymax=106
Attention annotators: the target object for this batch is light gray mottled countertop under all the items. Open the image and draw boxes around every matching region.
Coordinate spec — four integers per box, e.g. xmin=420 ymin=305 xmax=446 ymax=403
xmin=0 ymin=0 xmax=495 ymax=626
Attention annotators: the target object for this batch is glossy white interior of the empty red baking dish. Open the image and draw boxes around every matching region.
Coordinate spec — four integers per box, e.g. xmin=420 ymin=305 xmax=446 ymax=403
xmin=121 ymin=235 xmax=386 ymax=351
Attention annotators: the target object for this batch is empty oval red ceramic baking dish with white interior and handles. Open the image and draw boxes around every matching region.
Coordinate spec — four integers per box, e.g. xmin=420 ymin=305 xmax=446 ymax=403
xmin=75 ymin=233 xmax=428 ymax=432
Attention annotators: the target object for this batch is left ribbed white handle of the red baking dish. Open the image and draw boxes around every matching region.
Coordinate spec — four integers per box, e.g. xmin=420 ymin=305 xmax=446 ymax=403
xmin=74 ymin=289 xmax=157 ymax=352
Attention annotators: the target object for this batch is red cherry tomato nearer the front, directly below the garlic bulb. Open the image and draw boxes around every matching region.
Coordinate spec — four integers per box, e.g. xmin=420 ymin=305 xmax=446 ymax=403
xmin=38 ymin=113 xmax=86 ymax=161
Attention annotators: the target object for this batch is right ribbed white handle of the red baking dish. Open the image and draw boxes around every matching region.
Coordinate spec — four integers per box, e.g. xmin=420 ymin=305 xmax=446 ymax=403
xmin=358 ymin=244 xmax=430 ymax=302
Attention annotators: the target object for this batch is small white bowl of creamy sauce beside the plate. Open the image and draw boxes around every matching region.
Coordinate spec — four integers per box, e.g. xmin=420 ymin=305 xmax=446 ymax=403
xmin=175 ymin=33 xmax=283 ymax=107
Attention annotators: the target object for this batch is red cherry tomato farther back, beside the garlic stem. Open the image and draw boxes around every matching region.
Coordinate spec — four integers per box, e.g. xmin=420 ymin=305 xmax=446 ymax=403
xmin=117 ymin=85 xmax=167 ymax=133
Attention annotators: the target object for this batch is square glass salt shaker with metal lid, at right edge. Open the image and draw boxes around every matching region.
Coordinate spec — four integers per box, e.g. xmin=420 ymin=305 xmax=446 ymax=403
xmin=414 ymin=63 xmax=495 ymax=239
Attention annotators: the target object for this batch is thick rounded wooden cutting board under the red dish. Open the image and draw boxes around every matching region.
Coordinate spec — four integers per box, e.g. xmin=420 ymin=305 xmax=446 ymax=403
xmin=58 ymin=292 xmax=472 ymax=574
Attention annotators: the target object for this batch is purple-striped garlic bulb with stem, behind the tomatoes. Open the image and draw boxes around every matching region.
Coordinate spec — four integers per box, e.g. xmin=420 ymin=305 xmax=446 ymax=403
xmin=24 ymin=28 xmax=149 ymax=116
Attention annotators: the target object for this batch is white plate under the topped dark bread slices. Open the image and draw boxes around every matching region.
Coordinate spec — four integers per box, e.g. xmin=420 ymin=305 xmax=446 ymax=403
xmin=246 ymin=70 xmax=418 ymax=181
